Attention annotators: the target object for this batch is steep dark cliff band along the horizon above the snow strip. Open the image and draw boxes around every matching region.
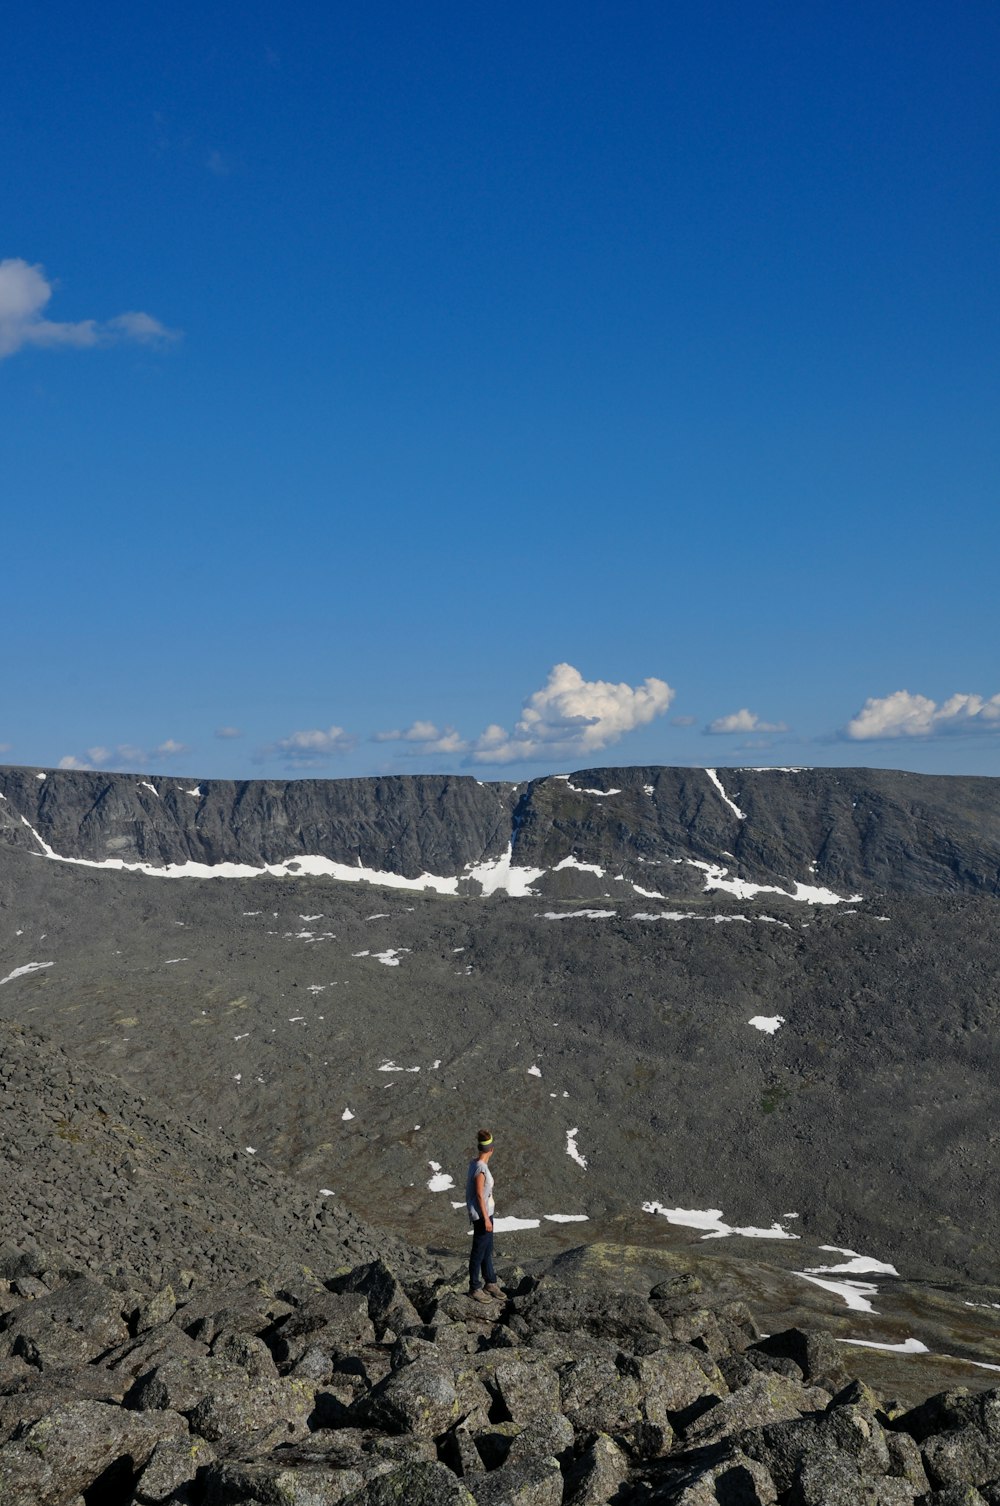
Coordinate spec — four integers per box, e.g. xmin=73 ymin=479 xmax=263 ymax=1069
xmin=0 ymin=768 xmax=1000 ymax=895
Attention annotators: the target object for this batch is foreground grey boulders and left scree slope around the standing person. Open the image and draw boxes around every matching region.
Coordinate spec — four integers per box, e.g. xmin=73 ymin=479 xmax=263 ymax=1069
xmin=0 ymin=1024 xmax=1000 ymax=1506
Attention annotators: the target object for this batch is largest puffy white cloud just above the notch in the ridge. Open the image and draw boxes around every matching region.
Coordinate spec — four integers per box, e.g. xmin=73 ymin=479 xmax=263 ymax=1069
xmin=471 ymin=664 xmax=675 ymax=764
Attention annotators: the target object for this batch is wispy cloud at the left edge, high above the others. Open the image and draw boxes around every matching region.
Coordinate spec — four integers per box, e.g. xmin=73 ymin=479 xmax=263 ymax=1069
xmin=0 ymin=256 xmax=178 ymax=360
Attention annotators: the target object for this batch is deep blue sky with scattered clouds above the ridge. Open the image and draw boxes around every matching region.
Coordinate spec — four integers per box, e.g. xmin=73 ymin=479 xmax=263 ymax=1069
xmin=0 ymin=0 xmax=1000 ymax=779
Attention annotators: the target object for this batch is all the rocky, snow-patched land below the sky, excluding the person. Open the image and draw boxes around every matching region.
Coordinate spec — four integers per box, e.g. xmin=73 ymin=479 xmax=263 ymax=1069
xmin=0 ymin=770 xmax=1000 ymax=1506
